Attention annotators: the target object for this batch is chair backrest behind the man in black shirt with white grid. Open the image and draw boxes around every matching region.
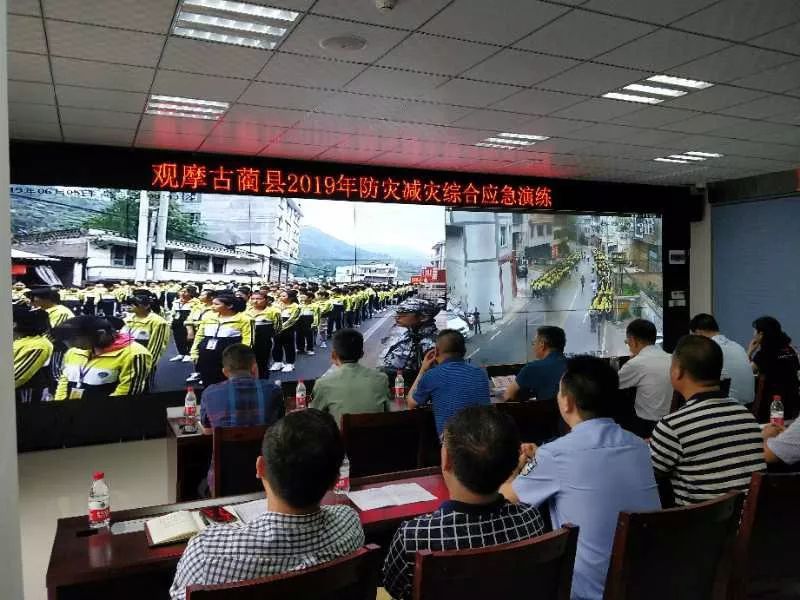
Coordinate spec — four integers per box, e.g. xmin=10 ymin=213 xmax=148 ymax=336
xmin=413 ymin=525 xmax=578 ymax=600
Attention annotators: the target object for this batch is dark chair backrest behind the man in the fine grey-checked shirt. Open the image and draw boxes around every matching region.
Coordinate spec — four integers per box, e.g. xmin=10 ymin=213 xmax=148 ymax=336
xmin=186 ymin=544 xmax=381 ymax=600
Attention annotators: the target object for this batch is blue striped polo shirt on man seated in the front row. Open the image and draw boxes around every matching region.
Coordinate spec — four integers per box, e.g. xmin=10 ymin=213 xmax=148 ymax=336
xmin=414 ymin=358 xmax=489 ymax=437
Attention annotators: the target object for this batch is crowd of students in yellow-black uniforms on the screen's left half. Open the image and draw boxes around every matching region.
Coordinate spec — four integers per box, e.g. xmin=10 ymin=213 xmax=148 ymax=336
xmin=12 ymin=281 xmax=413 ymax=402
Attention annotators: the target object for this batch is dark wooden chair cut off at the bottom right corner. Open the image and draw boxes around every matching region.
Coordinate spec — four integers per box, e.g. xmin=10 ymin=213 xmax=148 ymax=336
xmin=730 ymin=473 xmax=800 ymax=600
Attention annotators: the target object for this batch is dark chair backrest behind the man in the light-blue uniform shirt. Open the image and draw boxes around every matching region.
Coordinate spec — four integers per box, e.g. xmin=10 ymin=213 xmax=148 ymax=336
xmin=604 ymin=492 xmax=744 ymax=600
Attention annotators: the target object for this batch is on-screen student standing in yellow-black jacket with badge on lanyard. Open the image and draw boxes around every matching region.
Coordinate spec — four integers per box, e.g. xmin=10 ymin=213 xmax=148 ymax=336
xmin=191 ymin=294 xmax=253 ymax=387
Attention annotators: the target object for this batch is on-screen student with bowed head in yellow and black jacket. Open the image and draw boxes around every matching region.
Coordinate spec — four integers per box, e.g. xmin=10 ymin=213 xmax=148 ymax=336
xmin=53 ymin=315 xmax=153 ymax=400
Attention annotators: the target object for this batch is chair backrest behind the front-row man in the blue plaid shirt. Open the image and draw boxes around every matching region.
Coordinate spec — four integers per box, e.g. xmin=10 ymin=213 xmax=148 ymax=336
xmin=211 ymin=425 xmax=267 ymax=498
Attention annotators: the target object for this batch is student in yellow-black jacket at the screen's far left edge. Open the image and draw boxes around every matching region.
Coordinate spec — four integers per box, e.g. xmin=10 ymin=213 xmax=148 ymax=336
xmin=12 ymin=307 xmax=53 ymax=403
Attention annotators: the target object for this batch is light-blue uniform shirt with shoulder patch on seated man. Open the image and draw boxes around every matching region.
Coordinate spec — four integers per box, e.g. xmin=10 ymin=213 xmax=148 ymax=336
xmin=512 ymin=419 xmax=661 ymax=600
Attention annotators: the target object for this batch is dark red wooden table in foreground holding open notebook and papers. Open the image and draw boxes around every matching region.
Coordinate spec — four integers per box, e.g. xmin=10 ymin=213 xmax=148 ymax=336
xmin=46 ymin=468 xmax=448 ymax=600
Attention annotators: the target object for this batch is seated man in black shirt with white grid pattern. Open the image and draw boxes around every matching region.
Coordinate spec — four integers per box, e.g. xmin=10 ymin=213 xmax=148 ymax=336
xmin=383 ymin=406 xmax=544 ymax=600
